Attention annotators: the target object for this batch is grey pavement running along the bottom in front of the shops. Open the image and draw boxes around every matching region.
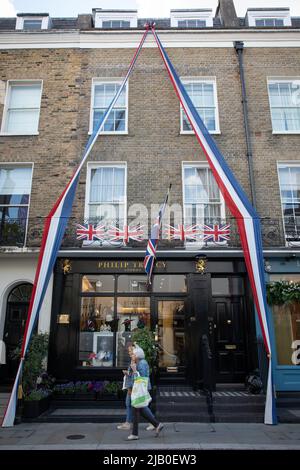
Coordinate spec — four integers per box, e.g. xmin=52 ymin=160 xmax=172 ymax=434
xmin=0 ymin=423 xmax=300 ymax=452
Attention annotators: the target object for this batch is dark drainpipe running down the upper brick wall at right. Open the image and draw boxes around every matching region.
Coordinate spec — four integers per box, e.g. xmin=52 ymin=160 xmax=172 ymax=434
xmin=234 ymin=41 xmax=257 ymax=209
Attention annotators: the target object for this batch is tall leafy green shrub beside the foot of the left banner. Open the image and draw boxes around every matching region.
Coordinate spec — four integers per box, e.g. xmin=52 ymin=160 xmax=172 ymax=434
xmin=12 ymin=333 xmax=49 ymax=400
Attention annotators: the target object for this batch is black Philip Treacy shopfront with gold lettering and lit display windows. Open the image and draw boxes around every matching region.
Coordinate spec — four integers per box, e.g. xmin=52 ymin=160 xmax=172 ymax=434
xmin=49 ymin=257 xmax=257 ymax=386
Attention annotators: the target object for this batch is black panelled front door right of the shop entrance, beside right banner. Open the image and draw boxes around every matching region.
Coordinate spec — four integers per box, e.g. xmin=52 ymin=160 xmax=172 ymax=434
xmin=213 ymin=297 xmax=246 ymax=383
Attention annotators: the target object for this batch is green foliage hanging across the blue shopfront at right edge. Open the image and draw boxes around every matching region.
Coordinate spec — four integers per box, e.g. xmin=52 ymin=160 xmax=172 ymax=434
xmin=267 ymin=281 xmax=300 ymax=306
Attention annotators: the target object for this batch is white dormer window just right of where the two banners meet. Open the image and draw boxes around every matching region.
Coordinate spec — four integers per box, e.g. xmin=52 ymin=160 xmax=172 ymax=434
xmin=171 ymin=9 xmax=213 ymax=28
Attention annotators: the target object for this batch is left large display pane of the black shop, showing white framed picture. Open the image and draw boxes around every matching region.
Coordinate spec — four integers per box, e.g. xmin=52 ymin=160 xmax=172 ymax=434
xmin=79 ymin=297 xmax=117 ymax=367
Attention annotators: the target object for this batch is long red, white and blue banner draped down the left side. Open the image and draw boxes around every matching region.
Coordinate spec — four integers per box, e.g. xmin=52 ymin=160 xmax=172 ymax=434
xmin=2 ymin=27 xmax=149 ymax=427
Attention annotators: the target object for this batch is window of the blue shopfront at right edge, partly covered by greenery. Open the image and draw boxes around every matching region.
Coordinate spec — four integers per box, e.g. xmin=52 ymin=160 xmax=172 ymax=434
xmin=270 ymin=274 xmax=300 ymax=366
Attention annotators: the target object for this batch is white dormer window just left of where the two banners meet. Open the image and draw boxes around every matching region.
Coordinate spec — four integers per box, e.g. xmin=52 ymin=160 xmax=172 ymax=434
xmin=93 ymin=8 xmax=137 ymax=29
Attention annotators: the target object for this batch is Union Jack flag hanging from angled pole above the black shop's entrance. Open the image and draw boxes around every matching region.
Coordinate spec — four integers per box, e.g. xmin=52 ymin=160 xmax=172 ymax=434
xmin=144 ymin=184 xmax=172 ymax=284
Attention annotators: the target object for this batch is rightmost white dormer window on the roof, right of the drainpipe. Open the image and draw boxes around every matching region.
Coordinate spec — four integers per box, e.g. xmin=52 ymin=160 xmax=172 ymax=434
xmin=246 ymin=8 xmax=292 ymax=28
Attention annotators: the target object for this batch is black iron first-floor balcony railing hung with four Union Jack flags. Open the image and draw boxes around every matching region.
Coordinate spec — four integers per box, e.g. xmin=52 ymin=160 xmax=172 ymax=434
xmin=0 ymin=217 xmax=300 ymax=250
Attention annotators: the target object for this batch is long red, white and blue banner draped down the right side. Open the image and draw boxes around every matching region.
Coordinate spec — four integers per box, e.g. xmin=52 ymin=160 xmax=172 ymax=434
xmin=151 ymin=25 xmax=277 ymax=424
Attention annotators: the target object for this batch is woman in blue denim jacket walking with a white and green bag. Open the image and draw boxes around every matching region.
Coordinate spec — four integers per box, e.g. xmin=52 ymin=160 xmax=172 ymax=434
xmin=127 ymin=346 xmax=164 ymax=441
